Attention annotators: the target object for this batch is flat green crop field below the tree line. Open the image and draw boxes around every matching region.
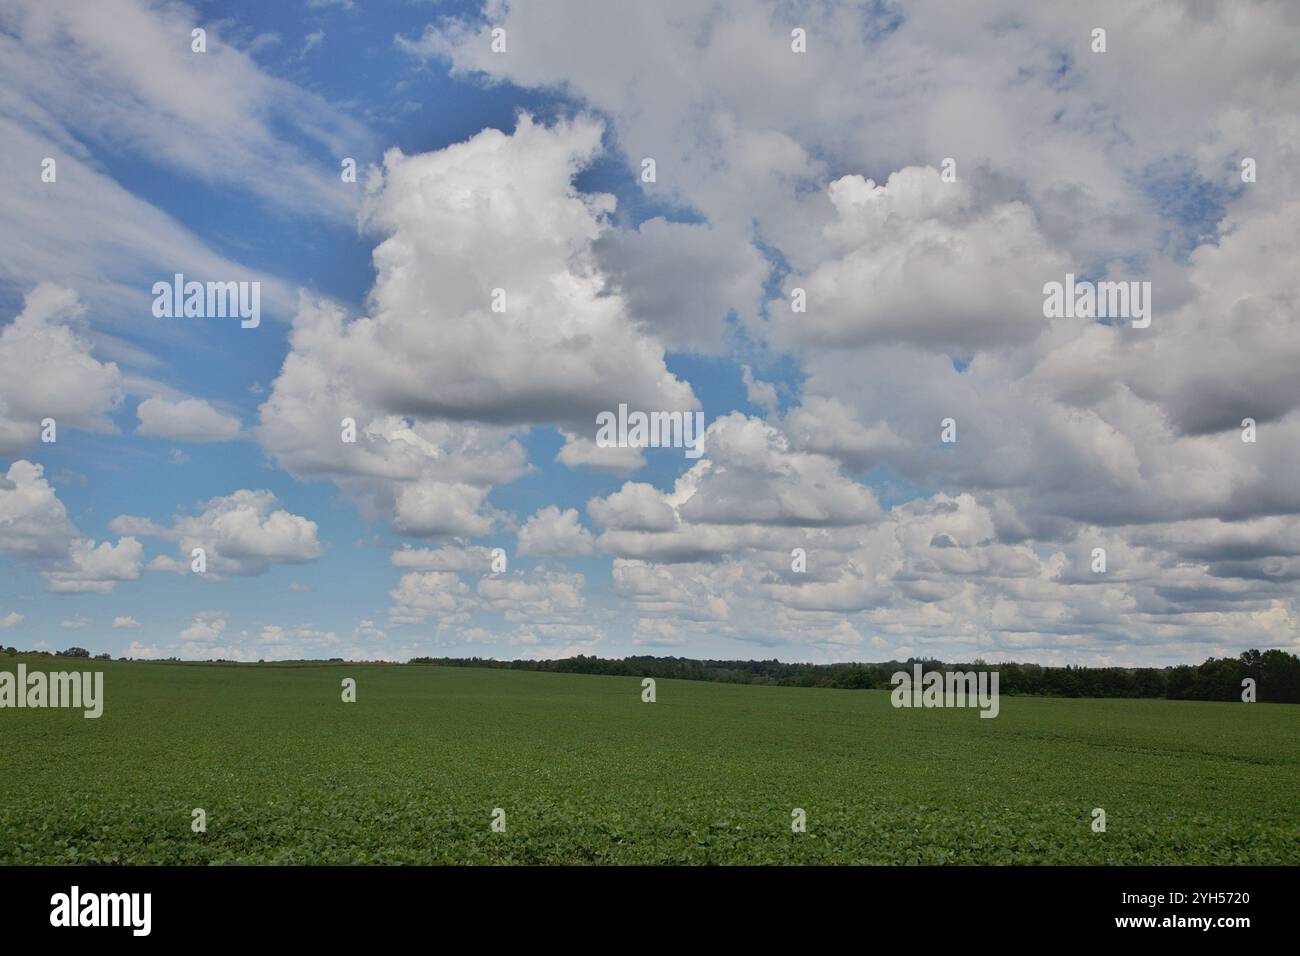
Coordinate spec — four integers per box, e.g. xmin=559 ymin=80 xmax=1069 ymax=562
xmin=0 ymin=657 xmax=1300 ymax=864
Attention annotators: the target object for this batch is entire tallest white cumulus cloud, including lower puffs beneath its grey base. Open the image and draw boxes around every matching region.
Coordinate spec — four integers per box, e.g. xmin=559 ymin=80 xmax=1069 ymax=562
xmin=259 ymin=116 xmax=698 ymax=537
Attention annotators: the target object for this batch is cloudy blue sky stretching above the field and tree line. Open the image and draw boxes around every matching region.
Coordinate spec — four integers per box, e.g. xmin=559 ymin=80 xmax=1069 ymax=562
xmin=0 ymin=0 xmax=1300 ymax=666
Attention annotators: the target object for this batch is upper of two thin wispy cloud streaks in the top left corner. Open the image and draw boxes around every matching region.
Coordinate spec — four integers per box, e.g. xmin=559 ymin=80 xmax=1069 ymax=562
xmin=0 ymin=0 xmax=369 ymax=219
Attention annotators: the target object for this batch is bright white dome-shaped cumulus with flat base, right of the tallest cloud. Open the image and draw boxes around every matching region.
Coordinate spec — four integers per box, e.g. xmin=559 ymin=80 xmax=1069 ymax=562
xmin=771 ymin=166 xmax=1070 ymax=355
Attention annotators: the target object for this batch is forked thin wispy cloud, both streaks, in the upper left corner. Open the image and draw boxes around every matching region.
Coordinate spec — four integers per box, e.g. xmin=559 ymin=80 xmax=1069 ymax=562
xmin=0 ymin=0 xmax=330 ymax=332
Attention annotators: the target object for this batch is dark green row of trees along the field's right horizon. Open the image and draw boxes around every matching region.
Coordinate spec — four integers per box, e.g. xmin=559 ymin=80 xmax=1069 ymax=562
xmin=411 ymin=650 xmax=1300 ymax=704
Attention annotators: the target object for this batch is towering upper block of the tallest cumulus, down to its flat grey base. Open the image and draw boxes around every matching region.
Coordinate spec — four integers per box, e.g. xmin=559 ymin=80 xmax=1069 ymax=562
xmin=353 ymin=114 xmax=697 ymax=429
